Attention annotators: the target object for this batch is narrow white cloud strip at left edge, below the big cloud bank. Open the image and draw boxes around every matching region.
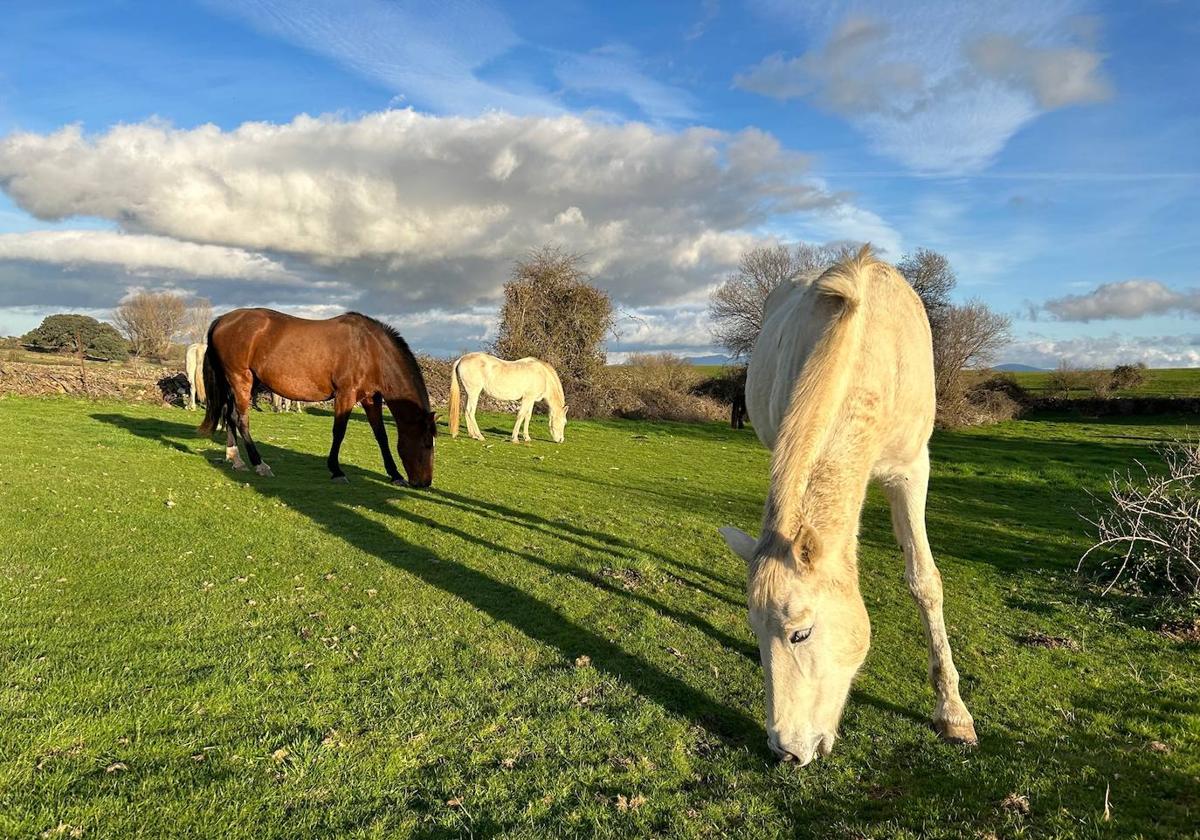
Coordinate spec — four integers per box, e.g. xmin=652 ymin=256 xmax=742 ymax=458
xmin=0 ymin=230 xmax=302 ymax=283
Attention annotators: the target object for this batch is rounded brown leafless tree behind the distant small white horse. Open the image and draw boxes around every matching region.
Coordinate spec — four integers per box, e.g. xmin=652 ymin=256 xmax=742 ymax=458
xmin=492 ymin=245 xmax=614 ymax=390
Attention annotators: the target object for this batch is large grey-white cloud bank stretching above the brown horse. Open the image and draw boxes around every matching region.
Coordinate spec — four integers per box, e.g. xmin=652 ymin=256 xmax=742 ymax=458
xmin=0 ymin=110 xmax=899 ymax=312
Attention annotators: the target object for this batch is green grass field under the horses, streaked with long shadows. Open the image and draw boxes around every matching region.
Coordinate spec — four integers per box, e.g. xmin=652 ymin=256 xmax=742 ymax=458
xmin=0 ymin=398 xmax=1200 ymax=838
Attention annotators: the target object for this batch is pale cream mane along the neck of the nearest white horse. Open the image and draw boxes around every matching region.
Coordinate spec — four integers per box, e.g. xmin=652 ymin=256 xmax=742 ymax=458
xmin=756 ymin=246 xmax=877 ymax=557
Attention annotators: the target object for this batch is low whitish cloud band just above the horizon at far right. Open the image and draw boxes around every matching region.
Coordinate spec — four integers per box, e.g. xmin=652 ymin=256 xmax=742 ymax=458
xmin=1004 ymin=334 xmax=1200 ymax=370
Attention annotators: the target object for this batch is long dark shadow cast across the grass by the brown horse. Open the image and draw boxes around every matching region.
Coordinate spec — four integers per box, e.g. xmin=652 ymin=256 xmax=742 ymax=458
xmin=91 ymin=414 xmax=766 ymax=752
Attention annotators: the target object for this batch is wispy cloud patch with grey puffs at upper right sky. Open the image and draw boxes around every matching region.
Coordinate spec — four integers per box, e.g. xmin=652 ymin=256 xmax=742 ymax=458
xmin=734 ymin=0 xmax=1110 ymax=173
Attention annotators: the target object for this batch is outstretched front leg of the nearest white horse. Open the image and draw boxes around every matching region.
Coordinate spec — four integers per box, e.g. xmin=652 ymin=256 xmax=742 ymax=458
xmin=884 ymin=451 xmax=977 ymax=744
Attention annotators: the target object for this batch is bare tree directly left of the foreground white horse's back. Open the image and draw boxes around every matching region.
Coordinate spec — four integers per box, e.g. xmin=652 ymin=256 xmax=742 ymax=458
xmin=708 ymin=242 xmax=851 ymax=356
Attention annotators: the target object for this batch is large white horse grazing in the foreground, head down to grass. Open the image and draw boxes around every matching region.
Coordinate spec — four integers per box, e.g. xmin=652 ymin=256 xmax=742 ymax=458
xmin=721 ymin=247 xmax=976 ymax=764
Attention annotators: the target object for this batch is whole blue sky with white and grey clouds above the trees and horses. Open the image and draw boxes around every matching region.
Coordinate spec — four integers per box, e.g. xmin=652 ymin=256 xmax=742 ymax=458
xmin=0 ymin=0 xmax=1200 ymax=367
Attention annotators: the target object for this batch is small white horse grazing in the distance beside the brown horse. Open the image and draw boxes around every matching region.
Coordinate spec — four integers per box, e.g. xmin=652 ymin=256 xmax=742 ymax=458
xmin=450 ymin=353 xmax=566 ymax=443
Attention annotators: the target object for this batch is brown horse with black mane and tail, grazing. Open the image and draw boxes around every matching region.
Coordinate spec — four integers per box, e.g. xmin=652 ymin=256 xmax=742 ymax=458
xmin=199 ymin=310 xmax=437 ymax=487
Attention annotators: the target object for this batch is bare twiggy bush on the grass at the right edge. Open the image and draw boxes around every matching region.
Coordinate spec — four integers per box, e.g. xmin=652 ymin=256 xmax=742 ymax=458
xmin=1076 ymin=440 xmax=1200 ymax=604
